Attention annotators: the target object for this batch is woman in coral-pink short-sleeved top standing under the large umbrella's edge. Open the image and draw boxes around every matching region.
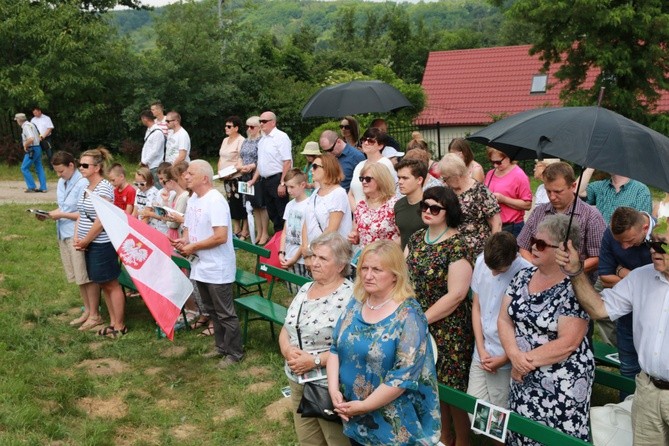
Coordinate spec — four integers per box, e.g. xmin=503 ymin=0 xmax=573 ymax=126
xmin=485 ymin=147 xmax=532 ymax=237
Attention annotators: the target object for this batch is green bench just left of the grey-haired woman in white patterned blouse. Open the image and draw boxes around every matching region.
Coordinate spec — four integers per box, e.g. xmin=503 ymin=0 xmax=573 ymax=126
xmin=235 ymin=263 xmax=312 ymax=343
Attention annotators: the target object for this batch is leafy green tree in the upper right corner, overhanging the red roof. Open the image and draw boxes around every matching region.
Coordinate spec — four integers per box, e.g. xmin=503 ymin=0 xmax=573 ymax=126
xmin=495 ymin=0 xmax=669 ymax=122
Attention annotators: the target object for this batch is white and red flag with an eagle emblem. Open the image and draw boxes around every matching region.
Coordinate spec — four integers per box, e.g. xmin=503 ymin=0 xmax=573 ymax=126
xmin=89 ymin=193 xmax=193 ymax=340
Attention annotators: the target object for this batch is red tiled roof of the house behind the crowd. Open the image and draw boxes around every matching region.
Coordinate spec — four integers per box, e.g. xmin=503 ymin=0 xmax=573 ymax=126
xmin=416 ymin=45 xmax=669 ymax=126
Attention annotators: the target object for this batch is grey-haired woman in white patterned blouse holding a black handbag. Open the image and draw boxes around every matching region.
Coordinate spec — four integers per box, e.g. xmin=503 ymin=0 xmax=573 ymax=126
xmin=279 ymin=232 xmax=353 ymax=446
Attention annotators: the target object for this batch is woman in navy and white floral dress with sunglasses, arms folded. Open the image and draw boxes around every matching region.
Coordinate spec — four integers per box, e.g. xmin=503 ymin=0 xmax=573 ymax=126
xmin=497 ymin=214 xmax=595 ymax=445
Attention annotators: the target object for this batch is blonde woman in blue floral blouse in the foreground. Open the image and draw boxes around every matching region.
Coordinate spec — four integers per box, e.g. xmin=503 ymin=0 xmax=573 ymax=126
xmin=327 ymin=240 xmax=441 ymax=445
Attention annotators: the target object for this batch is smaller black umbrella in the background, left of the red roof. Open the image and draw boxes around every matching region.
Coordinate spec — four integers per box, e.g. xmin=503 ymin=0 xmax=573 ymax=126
xmin=302 ymin=81 xmax=411 ymax=118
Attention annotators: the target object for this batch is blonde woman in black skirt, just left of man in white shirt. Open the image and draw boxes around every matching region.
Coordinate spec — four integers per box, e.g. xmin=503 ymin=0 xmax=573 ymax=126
xmin=237 ymin=116 xmax=269 ymax=245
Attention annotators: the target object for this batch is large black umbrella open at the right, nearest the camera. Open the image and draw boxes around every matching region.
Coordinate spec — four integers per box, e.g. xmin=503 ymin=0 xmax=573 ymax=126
xmin=467 ymin=107 xmax=669 ymax=191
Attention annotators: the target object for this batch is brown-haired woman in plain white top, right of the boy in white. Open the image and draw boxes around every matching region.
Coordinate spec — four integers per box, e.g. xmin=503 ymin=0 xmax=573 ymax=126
xmin=301 ymin=153 xmax=352 ymax=260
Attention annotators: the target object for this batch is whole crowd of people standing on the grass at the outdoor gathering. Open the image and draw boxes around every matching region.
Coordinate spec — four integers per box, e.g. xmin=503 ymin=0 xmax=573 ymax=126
xmin=22 ymin=103 xmax=669 ymax=445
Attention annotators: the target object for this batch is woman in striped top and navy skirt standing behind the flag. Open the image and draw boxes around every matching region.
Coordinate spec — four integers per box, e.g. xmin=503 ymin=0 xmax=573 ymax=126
xmin=74 ymin=147 xmax=127 ymax=338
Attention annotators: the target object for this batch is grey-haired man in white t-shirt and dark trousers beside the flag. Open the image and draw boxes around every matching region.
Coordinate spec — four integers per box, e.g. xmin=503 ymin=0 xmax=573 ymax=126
xmin=172 ymin=160 xmax=244 ymax=369
